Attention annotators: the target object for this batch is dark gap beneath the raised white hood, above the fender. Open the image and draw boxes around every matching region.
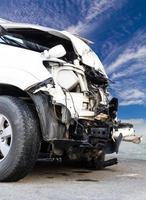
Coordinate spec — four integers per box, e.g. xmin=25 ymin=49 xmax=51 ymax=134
xmin=0 ymin=26 xmax=76 ymax=63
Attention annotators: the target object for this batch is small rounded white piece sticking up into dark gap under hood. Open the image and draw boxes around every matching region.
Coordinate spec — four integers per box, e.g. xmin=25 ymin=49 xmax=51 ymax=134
xmin=43 ymin=44 xmax=66 ymax=58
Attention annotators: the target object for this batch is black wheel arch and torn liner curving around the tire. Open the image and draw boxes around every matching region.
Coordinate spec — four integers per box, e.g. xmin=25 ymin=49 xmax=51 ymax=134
xmin=0 ymin=84 xmax=65 ymax=142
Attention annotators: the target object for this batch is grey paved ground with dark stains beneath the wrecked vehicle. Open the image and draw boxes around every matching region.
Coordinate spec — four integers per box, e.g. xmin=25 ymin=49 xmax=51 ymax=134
xmin=0 ymin=158 xmax=146 ymax=200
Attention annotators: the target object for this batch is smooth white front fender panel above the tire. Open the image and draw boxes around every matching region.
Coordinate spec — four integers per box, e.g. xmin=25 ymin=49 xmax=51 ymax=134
xmin=0 ymin=44 xmax=51 ymax=90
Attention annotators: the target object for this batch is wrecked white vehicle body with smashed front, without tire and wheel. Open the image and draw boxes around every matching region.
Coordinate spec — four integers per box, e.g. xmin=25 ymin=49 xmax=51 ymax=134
xmin=0 ymin=19 xmax=140 ymax=168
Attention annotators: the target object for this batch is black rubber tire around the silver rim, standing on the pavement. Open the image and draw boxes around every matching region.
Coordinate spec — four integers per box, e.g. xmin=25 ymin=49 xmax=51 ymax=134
xmin=0 ymin=96 xmax=40 ymax=182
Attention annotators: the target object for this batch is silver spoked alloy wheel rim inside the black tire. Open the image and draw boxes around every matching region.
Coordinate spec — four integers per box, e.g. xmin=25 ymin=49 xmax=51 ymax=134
xmin=0 ymin=114 xmax=13 ymax=162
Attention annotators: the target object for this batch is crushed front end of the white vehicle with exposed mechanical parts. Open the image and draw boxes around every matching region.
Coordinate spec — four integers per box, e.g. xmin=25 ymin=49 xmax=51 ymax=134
xmin=26 ymin=30 xmax=140 ymax=169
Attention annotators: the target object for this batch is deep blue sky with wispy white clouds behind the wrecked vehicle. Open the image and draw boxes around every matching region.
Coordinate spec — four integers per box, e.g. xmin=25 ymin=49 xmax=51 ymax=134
xmin=0 ymin=0 xmax=146 ymax=123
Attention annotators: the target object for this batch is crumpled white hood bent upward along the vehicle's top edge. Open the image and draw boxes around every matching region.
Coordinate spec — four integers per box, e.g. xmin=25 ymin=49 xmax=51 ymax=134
xmin=0 ymin=21 xmax=108 ymax=78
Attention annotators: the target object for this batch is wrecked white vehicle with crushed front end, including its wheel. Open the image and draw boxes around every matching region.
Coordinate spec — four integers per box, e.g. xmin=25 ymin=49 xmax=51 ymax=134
xmin=0 ymin=19 xmax=140 ymax=181
